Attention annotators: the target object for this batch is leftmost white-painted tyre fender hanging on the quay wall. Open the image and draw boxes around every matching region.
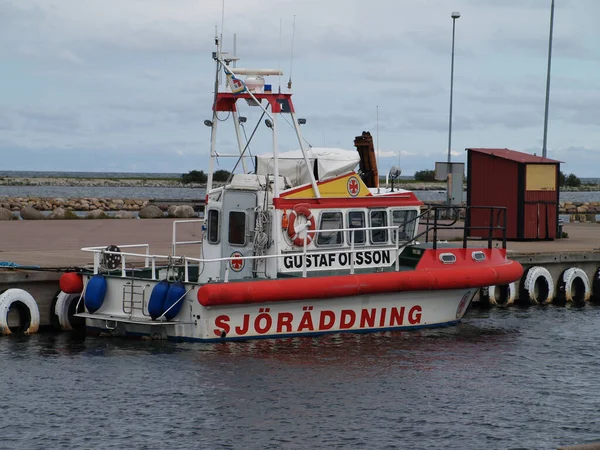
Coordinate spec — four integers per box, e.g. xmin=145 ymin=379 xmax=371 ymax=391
xmin=0 ymin=288 xmax=40 ymax=336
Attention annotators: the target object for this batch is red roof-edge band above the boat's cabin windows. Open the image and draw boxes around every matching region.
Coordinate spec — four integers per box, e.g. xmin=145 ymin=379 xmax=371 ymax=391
xmin=273 ymin=194 xmax=423 ymax=209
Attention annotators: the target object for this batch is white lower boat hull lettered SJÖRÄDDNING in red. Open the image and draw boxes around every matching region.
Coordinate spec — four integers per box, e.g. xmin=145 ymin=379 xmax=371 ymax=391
xmin=79 ymin=280 xmax=477 ymax=342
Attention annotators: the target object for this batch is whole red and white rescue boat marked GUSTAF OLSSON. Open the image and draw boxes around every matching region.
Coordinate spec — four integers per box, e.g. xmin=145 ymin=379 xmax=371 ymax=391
xmin=61 ymin=37 xmax=522 ymax=341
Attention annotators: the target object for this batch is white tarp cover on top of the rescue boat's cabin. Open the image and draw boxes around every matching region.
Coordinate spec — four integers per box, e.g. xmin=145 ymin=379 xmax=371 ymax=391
xmin=256 ymin=147 xmax=360 ymax=186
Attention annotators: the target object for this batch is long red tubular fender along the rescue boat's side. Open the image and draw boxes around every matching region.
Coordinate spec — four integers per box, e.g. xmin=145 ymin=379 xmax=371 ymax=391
xmin=198 ymin=255 xmax=523 ymax=306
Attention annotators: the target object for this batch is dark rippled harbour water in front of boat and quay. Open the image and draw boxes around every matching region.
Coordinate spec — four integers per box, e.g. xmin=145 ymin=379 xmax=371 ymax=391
xmin=0 ymin=306 xmax=600 ymax=450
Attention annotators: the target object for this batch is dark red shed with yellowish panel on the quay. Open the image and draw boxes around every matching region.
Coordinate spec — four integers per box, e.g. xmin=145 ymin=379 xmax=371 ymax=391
xmin=467 ymin=148 xmax=560 ymax=240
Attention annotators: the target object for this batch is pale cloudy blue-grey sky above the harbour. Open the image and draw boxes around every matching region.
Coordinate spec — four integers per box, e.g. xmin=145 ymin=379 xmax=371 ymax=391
xmin=0 ymin=0 xmax=600 ymax=177
